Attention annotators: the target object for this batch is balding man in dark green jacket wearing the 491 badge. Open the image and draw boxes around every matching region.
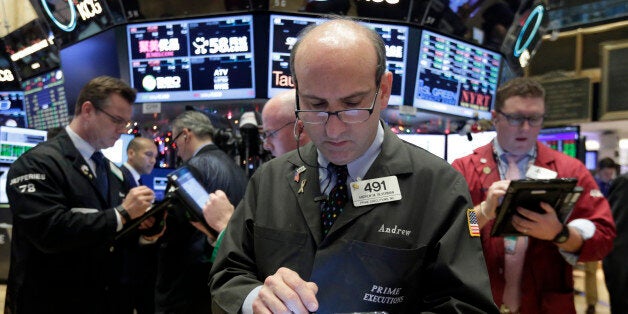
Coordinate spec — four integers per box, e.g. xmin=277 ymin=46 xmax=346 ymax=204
xmin=210 ymin=19 xmax=497 ymax=313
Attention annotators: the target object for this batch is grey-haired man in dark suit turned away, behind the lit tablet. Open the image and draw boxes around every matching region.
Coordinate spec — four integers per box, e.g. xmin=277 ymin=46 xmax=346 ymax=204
xmin=155 ymin=110 xmax=248 ymax=313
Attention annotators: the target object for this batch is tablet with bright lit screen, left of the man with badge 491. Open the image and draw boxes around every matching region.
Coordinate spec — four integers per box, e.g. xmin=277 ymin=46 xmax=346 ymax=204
xmin=168 ymin=166 xmax=218 ymax=237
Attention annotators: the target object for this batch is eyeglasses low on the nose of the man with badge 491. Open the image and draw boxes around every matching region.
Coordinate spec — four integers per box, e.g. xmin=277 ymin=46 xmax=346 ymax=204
xmin=295 ymin=84 xmax=379 ymax=124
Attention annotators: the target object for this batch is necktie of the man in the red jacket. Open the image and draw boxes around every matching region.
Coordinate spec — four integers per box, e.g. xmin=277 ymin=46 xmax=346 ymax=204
xmin=502 ymin=154 xmax=528 ymax=313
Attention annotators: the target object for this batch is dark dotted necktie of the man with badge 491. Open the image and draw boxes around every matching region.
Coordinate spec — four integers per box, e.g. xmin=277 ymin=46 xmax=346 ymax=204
xmin=321 ymin=163 xmax=349 ymax=236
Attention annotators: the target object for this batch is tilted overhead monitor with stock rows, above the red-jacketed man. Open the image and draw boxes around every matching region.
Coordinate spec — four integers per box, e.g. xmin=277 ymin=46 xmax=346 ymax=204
xmin=413 ymin=30 xmax=502 ymax=119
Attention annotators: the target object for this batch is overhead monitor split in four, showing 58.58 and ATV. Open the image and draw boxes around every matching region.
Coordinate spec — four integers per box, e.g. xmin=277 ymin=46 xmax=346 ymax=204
xmin=126 ymin=14 xmax=256 ymax=103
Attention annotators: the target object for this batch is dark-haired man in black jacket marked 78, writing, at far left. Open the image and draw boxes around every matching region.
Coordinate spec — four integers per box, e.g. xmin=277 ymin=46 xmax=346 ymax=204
xmin=5 ymin=76 xmax=154 ymax=313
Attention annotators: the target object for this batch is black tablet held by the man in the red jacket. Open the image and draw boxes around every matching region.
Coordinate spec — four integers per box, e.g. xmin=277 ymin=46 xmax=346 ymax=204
xmin=491 ymin=178 xmax=582 ymax=237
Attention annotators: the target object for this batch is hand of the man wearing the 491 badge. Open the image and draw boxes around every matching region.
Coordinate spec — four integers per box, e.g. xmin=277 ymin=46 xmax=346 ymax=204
xmin=253 ymin=267 xmax=318 ymax=314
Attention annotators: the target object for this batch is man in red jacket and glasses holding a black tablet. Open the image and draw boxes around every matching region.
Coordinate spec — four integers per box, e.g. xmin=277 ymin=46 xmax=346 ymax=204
xmin=453 ymin=78 xmax=615 ymax=313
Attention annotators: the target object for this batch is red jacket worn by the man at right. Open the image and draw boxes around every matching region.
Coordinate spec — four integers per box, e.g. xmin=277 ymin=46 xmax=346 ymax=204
xmin=453 ymin=142 xmax=615 ymax=314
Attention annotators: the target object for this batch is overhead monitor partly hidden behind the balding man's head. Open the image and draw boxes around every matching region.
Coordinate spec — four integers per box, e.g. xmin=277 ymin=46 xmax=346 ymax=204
xmin=268 ymin=14 xmax=410 ymax=105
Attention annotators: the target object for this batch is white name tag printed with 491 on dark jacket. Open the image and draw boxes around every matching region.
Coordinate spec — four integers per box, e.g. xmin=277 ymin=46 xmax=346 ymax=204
xmin=351 ymin=176 xmax=401 ymax=207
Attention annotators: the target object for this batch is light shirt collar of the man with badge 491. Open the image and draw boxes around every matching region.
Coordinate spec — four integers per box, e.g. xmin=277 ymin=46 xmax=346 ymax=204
xmin=317 ymin=122 xmax=384 ymax=194
